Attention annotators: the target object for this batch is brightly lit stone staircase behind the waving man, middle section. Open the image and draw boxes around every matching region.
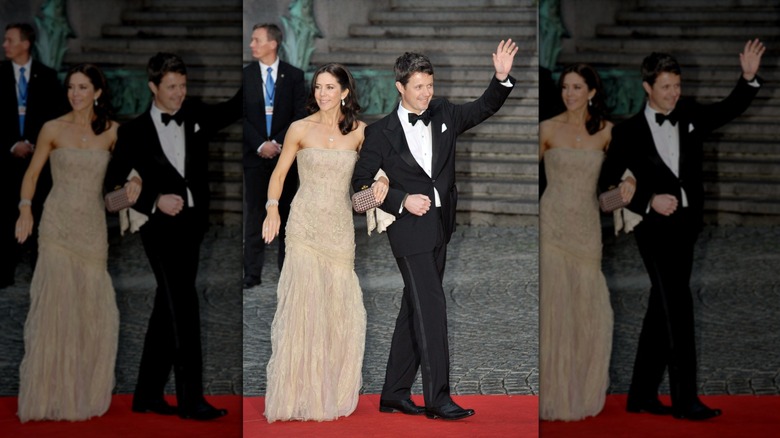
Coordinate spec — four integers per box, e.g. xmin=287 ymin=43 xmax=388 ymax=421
xmin=311 ymin=0 xmax=539 ymax=225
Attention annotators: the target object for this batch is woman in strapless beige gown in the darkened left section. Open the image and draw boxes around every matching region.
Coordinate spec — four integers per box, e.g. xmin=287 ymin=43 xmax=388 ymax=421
xmin=16 ymin=64 xmax=140 ymax=422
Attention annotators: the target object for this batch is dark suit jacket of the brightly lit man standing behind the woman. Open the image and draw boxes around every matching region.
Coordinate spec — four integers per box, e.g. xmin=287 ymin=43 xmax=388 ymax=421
xmin=243 ymin=61 xmax=306 ymax=167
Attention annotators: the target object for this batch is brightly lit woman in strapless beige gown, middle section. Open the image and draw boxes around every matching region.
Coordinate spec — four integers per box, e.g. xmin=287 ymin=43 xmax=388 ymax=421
xmin=263 ymin=64 xmax=387 ymax=423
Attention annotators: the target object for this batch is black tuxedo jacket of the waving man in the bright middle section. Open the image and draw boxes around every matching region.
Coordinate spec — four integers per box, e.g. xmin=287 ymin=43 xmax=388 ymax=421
xmin=352 ymin=77 xmax=515 ymax=257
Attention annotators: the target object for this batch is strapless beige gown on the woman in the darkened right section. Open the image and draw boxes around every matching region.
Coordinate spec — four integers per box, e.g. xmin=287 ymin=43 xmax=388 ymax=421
xmin=539 ymin=147 xmax=612 ymax=420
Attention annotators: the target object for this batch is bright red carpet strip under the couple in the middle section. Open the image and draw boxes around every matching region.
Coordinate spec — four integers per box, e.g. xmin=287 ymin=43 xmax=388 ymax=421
xmin=244 ymin=394 xmax=539 ymax=438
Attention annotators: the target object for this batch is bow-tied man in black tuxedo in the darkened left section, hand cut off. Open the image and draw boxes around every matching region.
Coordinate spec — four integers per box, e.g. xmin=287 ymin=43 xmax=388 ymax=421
xmin=105 ymin=53 xmax=241 ymax=420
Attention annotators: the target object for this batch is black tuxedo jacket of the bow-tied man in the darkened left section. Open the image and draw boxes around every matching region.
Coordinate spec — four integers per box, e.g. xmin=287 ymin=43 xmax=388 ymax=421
xmin=105 ymin=90 xmax=242 ymax=230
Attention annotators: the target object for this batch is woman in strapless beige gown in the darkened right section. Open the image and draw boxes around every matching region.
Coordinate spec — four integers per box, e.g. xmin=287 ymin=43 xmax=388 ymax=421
xmin=539 ymin=64 xmax=634 ymax=420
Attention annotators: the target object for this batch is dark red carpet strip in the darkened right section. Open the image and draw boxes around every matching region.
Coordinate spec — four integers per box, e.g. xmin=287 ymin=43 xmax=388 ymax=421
xmin=540 ymin=395 xmax=780 ymax=438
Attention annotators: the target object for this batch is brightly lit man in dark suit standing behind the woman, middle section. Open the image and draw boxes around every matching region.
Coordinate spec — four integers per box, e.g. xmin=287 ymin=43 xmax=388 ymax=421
xmin=243 ymin=24 xmax=306 ymax=289
